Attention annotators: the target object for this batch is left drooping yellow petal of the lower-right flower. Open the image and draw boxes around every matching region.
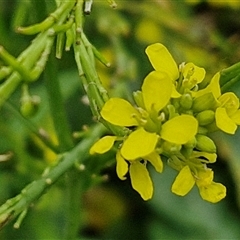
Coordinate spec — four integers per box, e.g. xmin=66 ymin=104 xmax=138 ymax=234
xmin=171 ymin=166 xmax=195 ymax=196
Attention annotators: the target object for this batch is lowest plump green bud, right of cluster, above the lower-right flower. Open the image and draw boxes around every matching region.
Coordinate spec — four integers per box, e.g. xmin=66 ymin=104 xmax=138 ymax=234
xmin=196 ymin=134 xmax=216 ymax=153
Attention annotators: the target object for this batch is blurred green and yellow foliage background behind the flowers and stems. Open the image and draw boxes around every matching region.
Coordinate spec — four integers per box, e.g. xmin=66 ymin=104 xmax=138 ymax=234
xmin=0 ymin=0 xmax=240 ymax=240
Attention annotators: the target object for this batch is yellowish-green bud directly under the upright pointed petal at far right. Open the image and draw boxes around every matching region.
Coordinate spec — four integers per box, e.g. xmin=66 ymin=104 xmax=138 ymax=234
xmin=192 ymin=93 xmax=217 ymax=112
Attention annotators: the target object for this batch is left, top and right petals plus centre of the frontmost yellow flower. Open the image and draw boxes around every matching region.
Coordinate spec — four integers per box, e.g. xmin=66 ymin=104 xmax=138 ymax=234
xmin=101 ymin=71 xmax=198 ymax=145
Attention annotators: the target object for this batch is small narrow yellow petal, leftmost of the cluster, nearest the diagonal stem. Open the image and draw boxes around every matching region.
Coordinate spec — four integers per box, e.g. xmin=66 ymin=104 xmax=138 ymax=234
xmin=89 ymin=136 xmax=117 ymax=154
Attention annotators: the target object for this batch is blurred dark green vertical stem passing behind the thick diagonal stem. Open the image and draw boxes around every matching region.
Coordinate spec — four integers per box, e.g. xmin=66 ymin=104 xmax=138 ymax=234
xmin=45 ymin=50 xmax=84 ymax=239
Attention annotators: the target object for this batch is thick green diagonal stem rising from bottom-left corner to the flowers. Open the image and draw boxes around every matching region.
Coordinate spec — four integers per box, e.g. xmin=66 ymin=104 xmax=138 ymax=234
xmin=0 ymin=125 xmax=104 ymax=229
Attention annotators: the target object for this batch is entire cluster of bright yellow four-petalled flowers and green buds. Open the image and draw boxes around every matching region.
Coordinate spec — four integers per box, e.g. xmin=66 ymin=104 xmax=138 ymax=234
xmin=90 ymin=43 xmax=240 ymax=203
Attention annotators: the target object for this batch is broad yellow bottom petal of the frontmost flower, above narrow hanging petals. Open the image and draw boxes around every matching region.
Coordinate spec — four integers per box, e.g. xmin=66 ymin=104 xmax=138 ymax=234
xmin=121 ymin=128 xmax=158 ymax=160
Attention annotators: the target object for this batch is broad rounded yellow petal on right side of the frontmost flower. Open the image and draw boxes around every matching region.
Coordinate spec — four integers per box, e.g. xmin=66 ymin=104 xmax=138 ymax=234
xmin=161 ymin=115 xmax=198 ymax=144
